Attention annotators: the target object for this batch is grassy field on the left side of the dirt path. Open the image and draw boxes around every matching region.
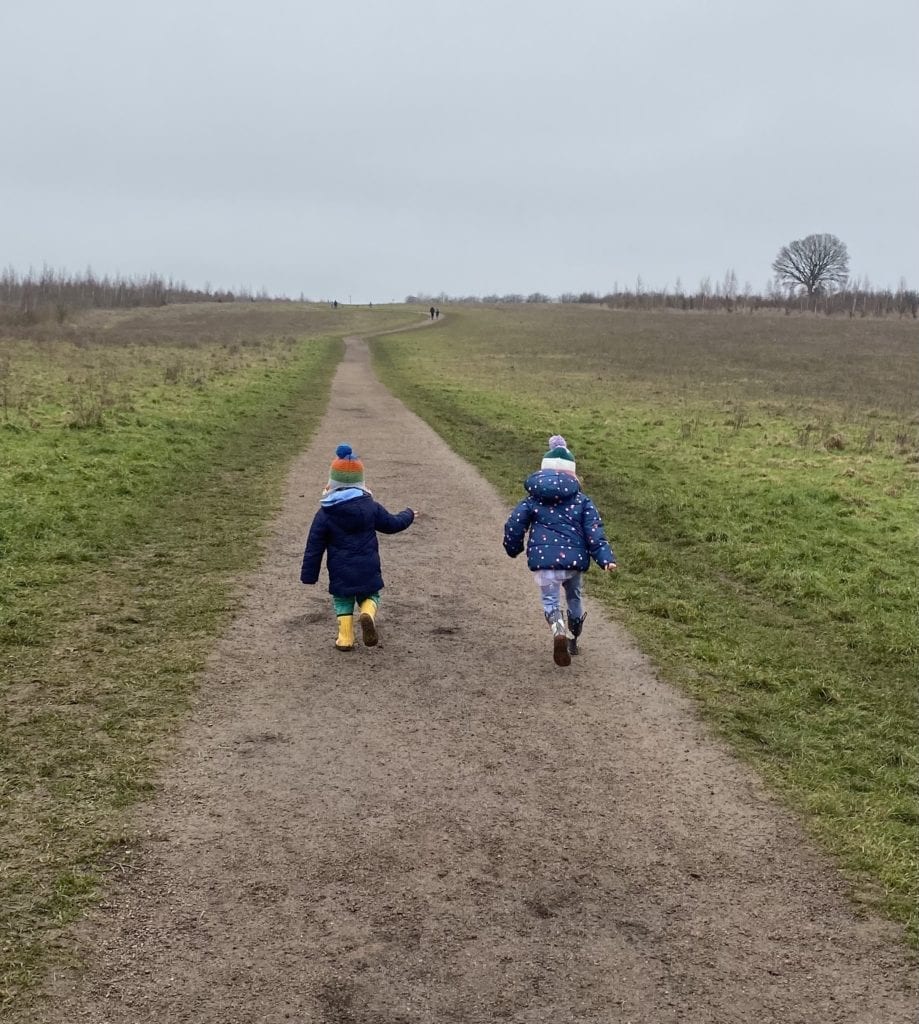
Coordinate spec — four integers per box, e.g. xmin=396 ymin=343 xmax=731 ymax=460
xmin=0 ymin=304 xmax=415 ymax=1016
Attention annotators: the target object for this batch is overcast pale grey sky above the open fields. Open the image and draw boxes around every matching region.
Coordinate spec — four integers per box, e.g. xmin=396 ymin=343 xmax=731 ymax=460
xmin=0 ymin=0 xmax=919 ymax=302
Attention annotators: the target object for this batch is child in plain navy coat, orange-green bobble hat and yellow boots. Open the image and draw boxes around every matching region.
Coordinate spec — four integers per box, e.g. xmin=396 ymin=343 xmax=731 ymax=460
xmin=300 ymin=444 xmax=416 ymax=650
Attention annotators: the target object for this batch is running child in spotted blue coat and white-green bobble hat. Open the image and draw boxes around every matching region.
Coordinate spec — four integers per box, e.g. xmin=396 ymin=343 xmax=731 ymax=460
xmin=504 ymin=434 xmax=617 ymax=666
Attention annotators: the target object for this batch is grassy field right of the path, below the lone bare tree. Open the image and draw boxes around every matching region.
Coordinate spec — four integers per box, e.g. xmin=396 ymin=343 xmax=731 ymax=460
xmin=374 ymin=306 xmax=919 ymax=940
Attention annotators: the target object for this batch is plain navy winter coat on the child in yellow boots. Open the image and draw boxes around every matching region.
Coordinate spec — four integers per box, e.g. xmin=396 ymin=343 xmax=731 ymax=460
xmin=300 ymin=492 xmax=415 ymax=597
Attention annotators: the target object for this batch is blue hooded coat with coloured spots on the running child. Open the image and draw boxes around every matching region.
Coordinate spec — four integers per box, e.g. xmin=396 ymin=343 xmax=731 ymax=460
xmin=504 ymin=469 xmax=616 ymax=572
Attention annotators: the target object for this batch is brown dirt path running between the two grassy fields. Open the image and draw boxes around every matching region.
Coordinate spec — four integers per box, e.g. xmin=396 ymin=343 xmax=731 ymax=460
xmin=34 ymin=339 xmax=917 ymax=1024
